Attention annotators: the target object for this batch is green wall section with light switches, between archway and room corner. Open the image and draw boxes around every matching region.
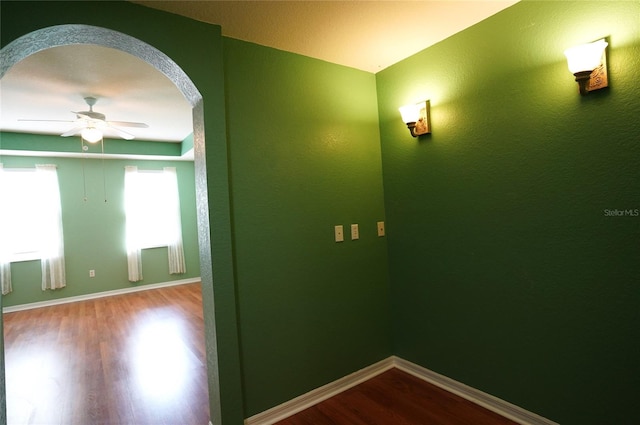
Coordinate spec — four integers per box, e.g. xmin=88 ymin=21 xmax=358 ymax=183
xmin=224 ymin=38 xmax=391 ymax=416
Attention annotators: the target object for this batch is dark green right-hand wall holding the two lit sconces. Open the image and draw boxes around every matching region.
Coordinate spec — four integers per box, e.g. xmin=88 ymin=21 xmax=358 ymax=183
xmin=376 ymin=2 xmax=640 ymax=425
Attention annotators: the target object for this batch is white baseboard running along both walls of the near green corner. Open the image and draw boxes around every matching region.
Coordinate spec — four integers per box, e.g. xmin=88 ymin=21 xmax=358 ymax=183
xmin=244 ymin=356 xmax=558 ymax=425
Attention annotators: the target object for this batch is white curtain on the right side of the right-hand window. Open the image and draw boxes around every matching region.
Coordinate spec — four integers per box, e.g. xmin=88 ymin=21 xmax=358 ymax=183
xmin=164 ymin=167 xmax=187 ymax=274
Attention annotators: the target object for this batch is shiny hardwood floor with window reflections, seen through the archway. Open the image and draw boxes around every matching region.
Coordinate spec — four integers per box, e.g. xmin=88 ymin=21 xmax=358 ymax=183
xmin=4 ymin=283 xmax=209 ymax=425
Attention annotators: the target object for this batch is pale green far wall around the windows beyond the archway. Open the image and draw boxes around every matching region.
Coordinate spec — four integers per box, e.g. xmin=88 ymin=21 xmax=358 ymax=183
xmin=0 ymin=147 xmax=200 ymax=307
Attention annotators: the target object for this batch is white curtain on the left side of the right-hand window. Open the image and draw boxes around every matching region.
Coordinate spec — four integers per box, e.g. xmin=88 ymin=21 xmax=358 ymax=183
xmin=124 ymin=166 xmax=143 ymax=282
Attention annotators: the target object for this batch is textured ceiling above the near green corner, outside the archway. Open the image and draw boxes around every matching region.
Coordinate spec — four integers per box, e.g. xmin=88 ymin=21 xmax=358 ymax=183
xmin=133 ymin=0 xmax=517 ymax=73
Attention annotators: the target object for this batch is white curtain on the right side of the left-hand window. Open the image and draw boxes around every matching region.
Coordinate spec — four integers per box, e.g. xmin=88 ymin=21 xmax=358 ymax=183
xmin=36 ymin=164 xmax=67 ymax=291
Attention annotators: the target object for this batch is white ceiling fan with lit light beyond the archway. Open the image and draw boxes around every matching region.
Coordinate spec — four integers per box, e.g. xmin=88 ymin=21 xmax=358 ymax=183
xmin=20 ymin=96 xmax=149 ymax=143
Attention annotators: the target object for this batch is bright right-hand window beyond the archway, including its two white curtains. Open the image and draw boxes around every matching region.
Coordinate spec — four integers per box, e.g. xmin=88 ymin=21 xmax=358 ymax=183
xmin=124 ymin=166 xmax=186 ymax=282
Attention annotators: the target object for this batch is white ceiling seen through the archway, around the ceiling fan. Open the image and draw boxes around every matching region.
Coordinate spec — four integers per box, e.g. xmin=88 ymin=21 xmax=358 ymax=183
xmin=0 ymin=45 xmax=193 ymax=142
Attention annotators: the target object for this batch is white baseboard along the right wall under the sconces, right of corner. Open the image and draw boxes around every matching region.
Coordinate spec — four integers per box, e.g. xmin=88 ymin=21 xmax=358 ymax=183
xmin=392 ymin=356 xmax=559 ymax=425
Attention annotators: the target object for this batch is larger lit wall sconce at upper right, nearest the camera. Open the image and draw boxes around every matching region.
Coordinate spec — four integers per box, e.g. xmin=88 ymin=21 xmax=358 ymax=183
xmin=564 ymin=39 xmax=609 ymax=95
